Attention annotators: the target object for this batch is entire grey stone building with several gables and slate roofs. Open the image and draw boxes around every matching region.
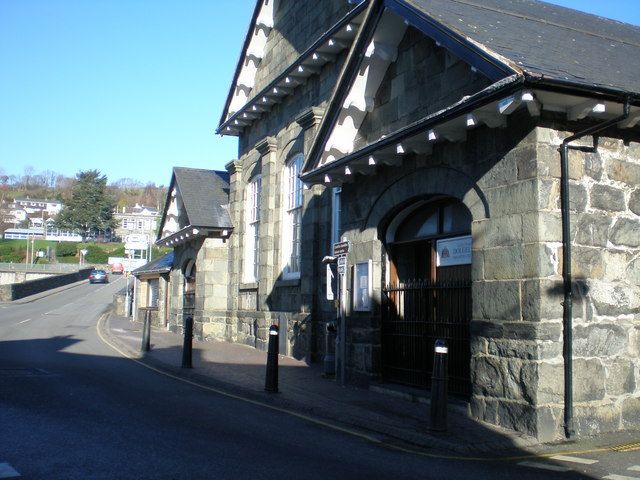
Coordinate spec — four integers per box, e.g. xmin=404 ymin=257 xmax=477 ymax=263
xmin=162 ymin=0 xmax=640 ymax=440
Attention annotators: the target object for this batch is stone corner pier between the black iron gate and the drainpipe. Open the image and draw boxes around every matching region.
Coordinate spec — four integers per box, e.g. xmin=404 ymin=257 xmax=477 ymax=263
xmin=471 ymin=126 xmax=562 ymax=439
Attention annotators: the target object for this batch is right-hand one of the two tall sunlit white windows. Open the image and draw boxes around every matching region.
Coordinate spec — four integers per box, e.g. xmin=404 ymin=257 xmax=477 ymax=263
xmin=282 ymin=154 xmax=303 ymax=279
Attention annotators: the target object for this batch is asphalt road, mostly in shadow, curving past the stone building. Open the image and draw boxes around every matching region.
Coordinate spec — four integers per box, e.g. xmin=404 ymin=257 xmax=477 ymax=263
xmin=0 ymin=278 xmax=640 ymax=480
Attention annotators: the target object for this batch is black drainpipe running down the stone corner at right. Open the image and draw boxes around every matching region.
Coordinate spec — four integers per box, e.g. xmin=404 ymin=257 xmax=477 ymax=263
xmin=560 ymin=97 xmax=629 ymax=438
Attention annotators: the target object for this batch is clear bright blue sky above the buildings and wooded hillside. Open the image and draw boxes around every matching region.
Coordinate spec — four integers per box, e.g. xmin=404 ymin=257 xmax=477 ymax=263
xmin=0 ymin=0 xmax=640 ymax=185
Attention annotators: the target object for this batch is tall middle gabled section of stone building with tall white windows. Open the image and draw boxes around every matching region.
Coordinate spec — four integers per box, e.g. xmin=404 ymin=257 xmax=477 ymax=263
xmin=219 ymin=0 xmax=365 ymax=360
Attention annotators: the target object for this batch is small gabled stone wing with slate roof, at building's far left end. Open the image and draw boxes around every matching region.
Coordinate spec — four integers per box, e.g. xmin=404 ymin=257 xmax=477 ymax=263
xmin=157 ymin=167 xmax=233 ymax=338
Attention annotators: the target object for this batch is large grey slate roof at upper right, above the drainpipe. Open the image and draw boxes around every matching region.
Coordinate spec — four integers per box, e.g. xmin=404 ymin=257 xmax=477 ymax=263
xmin=399 ymin=0 xmax=640 ymax=93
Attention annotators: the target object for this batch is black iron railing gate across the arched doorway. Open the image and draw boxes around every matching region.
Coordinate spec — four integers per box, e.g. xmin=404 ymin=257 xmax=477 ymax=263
xmin=382 ymin=280 xmax=471 ymax=397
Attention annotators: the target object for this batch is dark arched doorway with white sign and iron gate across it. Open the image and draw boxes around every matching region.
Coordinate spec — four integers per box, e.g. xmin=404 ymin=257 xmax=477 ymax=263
xmin=382 ymin=198 xmax=471 ymax=396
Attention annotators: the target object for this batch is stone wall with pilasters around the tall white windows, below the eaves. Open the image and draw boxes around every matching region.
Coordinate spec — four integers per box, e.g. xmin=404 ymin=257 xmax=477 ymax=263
xmin=226 ymin=114 xmax=330 ymax=358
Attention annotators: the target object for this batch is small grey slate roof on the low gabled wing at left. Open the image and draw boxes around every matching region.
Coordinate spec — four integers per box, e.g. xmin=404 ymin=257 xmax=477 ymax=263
xmin=173 ymin=167 xmax=233 ymax=228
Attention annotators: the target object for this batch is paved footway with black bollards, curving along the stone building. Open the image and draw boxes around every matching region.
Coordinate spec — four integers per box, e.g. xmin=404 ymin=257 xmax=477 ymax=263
xmin=98 ymin=312 xmax=537 ymax=458
